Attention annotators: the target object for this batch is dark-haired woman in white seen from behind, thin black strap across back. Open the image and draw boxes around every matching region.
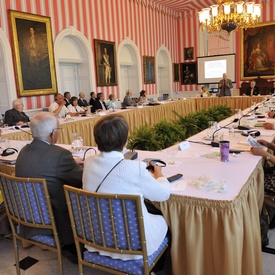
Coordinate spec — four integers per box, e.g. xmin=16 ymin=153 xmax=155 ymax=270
xmin=83 ymin=115 xmax=170 ymax=260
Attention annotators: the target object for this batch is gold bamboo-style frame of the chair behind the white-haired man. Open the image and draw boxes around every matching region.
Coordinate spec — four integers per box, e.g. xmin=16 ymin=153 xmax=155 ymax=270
xmin=0 ymin=174 xmax=63 ymax=275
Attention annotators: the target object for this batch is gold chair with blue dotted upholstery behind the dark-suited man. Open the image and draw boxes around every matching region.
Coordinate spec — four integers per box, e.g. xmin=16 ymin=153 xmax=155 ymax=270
xmin=0 ymin=173 xmax=63 ymax=274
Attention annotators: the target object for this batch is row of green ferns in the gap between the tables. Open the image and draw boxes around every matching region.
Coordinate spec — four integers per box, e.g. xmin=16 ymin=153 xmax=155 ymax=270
xmin=127 ymin=105 xmax=232 ymax=151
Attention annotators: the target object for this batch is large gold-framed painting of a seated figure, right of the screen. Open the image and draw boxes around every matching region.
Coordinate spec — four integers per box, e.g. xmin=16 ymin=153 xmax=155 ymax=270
xmin=240 ymin=21 xmax=275 ymax=80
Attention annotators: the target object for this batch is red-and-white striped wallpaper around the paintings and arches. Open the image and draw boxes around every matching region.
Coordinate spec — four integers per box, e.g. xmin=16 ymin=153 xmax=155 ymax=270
xmin=0 ymin=0 xmax=275 ymax=109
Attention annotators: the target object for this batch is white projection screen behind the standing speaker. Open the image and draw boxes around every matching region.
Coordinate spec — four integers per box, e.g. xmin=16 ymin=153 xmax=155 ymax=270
xmin=198 ymin=54 xmax=236 ymax=84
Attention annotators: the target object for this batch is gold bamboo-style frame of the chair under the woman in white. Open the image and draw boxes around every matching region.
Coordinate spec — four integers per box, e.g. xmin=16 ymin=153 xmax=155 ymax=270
xmin=64 ymin=185 xmax=168 ymax=275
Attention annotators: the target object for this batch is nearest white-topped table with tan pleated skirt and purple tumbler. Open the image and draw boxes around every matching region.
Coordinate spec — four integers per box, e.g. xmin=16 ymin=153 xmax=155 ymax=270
xmin=0 ymin=98 xmax=275 ymax=275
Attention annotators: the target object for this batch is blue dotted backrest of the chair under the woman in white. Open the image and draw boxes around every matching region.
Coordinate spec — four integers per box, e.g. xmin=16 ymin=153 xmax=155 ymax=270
xmin=69 ymin=192 xmax=141 ymax=250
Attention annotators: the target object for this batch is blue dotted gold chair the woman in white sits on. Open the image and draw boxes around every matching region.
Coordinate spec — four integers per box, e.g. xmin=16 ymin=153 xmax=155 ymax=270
xmin=64 ymin=185 xmax=168 ymax=275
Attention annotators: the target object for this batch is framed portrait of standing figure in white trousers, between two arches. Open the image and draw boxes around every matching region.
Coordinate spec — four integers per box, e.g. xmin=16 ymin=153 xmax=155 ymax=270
xmin=95 ymin=39 xmax=117 ymax=86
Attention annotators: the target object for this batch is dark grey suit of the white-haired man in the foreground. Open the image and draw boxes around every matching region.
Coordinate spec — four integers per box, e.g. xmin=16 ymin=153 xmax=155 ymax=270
xmin=15 ymin=139 xmax=83 ymax=245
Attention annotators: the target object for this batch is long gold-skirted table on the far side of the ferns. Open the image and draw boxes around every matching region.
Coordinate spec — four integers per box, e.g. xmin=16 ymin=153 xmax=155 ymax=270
xmin=2 ymin=96 xmax=264 ymax=146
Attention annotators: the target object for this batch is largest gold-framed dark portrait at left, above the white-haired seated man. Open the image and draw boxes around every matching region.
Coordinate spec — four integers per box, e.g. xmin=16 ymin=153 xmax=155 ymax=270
xmin=9 ymin=10 xmax=57 ymax=96
